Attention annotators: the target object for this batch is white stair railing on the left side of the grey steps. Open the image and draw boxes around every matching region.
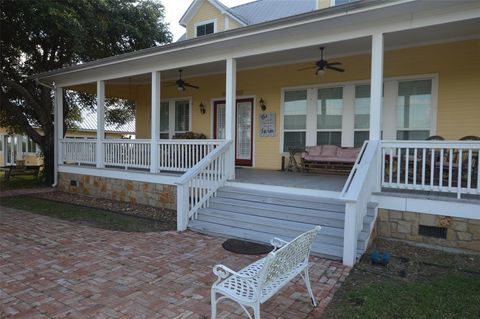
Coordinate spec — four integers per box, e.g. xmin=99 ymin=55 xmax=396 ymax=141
xmin=176 ymin=141 xmax=234 ymax=231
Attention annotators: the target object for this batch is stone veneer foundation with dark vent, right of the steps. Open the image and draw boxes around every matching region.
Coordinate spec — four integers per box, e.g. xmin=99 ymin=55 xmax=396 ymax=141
xmin=376 ymin=209 xmax=480 ymax=252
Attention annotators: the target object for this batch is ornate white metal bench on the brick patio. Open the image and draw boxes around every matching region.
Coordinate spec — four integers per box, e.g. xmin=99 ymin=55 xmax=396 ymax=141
xmin=212 ymin=226 xmax=320 ymax=319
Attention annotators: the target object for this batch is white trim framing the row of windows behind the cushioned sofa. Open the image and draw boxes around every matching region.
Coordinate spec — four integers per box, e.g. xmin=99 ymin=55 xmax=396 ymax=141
xmin=279 ymin=74 xmax=438 ymax=156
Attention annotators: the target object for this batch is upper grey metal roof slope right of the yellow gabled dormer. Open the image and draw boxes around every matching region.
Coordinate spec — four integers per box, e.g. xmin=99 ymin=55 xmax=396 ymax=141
xmin=228 ymin=0 xmax=317 ymax=25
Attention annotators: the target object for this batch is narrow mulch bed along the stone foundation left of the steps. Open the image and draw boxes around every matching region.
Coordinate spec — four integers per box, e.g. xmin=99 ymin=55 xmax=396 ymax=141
xmin=31 ymin=191 xmax=177 ymax=229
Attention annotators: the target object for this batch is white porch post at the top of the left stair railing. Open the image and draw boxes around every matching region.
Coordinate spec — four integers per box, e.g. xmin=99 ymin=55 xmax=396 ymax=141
xmin=225 ymin=58 xmax=237 ymax=179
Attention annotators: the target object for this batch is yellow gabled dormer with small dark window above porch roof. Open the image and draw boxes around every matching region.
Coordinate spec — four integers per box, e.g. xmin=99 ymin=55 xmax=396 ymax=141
xmin=180 ymin=0 xmax=246 ymax=39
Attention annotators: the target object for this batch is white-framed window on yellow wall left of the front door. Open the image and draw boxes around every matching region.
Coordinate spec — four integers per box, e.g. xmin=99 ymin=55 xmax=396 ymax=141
xmin=160 ymin=100 xmax=191 ymax=139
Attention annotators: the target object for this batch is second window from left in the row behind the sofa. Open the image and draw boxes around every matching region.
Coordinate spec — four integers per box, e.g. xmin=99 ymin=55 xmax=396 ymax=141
xmin=317 ymin=87 xmax=343 ymax=146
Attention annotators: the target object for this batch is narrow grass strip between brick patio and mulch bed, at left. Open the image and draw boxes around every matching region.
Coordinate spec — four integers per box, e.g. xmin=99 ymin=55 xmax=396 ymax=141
xmin=0 ymin=196 xmax=173 ymax=232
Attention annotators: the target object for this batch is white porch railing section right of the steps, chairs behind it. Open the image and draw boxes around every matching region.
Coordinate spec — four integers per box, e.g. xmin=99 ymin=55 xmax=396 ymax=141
xmin=381 ymin=141 xmax=480 ymax=198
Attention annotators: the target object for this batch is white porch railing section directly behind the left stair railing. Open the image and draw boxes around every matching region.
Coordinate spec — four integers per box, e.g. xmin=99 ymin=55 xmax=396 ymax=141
xmin=158 ymin=140 xmax=223 ymax=172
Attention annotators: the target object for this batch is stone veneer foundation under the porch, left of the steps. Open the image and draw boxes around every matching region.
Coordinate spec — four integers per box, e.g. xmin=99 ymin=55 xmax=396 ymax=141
xmin=58 ymin=173 xmax=177 ymax=210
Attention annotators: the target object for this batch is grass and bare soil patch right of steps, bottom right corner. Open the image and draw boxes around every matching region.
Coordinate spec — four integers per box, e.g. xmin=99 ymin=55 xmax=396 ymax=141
xmin=324 ymin=240 xmax=480 ymax=319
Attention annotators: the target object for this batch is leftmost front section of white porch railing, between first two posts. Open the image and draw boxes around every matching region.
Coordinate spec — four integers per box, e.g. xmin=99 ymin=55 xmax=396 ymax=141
xmin=60 ymin=139 xmax=97 ymax=165
